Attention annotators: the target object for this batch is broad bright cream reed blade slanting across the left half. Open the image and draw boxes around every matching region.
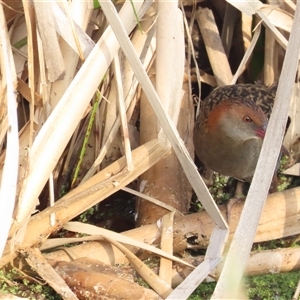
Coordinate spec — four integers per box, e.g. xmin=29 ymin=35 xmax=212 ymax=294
xmin=17 ymin=2 xmax=148 ymax=240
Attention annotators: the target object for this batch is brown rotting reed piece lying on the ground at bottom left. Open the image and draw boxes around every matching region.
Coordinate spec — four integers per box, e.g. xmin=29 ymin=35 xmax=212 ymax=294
xmin=50 ymin=258 xmax=162 ymax=300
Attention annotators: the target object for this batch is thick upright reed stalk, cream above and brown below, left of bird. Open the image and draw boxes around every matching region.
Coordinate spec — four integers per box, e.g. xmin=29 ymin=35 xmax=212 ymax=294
xmin=137 ymin=1 xmax=193 ymax=225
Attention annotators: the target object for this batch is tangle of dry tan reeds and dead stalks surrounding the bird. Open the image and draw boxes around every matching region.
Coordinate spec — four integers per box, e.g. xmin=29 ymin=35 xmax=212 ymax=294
xmin=0 ymin=0 xmax=300 ymax=299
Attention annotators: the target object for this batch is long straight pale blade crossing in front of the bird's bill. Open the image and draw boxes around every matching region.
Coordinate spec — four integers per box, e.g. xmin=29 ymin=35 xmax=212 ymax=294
xmin=212 ymin=2 xmax=300 ymax=299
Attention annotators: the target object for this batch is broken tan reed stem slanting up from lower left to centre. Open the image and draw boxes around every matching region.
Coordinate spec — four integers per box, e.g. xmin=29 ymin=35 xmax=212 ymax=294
xmin=0 ymin=140 xmax=169 ymax=266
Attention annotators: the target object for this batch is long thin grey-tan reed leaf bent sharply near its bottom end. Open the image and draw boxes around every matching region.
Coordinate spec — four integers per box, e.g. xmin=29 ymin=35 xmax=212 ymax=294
xmin=101 ymin=8 xmax=228 ymax=297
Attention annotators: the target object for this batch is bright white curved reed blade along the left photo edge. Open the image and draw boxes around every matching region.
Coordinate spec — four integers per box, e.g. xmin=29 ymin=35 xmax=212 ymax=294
xmin=0 ymin=3 xmax=19 ymax=257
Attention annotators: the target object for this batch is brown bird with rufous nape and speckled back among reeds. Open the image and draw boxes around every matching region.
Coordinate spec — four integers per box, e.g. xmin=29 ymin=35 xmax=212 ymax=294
xmin=194 ymin=84 xmax=285 ymax=182
